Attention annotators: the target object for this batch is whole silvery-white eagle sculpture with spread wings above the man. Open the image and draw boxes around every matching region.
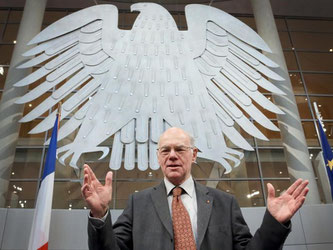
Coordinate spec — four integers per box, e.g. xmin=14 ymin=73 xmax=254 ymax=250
xmin=15 ymin=3 xmax=284 ymax=173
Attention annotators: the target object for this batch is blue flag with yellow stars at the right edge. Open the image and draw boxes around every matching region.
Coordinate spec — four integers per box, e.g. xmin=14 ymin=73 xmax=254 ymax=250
xmin=318 ymin=121 xmax=333 ymax=199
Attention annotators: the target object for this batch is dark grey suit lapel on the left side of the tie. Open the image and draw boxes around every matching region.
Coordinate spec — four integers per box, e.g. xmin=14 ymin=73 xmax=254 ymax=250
xmin=151 ymin=181 xmax=173 ymax=237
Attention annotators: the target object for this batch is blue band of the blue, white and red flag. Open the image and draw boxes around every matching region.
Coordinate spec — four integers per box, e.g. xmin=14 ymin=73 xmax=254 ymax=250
xmin=42 ymin=115 xmax=59 ymax=181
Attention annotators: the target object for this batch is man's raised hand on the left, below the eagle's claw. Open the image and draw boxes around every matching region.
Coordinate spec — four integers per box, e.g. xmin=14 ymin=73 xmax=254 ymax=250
xmin=81 ymin=164 xmax=112 ymax=218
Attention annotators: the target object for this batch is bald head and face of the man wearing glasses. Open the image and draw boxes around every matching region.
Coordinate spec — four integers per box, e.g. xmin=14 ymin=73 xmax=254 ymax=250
xmin=157 ymin=128 xmax=197 ymax=185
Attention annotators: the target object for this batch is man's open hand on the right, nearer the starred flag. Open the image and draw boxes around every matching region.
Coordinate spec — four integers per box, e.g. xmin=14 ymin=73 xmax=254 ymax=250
xmin=267 ymin=179 xmax=309 ymax=223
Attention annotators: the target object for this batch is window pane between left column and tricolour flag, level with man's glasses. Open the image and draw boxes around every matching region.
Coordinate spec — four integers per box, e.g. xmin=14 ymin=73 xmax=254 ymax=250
xmin=11 ymin=148 xmax=43 ymax=179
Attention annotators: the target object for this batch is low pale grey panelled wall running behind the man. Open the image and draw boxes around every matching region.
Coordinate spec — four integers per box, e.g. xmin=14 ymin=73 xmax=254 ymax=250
xmin=0 ymin=205 xmax=333 ymax=250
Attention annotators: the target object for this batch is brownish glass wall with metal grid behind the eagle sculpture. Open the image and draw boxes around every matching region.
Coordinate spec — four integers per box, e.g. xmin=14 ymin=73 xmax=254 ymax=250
xmin=0 ymin=6 xmax=333 ymax=209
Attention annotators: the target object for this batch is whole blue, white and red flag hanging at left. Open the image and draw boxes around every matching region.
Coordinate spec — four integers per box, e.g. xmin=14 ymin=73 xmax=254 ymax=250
xmin=28 ymin=115 xmax=59 ymax=250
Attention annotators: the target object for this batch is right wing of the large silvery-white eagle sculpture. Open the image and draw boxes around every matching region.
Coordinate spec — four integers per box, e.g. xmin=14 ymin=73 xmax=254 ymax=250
xmin=184 ymin=4 xmax=284 ymax=154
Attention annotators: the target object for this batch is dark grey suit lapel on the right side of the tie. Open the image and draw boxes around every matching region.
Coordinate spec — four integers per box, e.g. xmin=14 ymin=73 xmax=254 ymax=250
xmin=195 ymin=182 xmax=213 ymax=249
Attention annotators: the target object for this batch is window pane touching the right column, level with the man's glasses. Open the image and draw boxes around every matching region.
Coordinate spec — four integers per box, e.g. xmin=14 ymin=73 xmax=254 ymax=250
xmin=259 ymin=149 xmax=289 ymax=178
